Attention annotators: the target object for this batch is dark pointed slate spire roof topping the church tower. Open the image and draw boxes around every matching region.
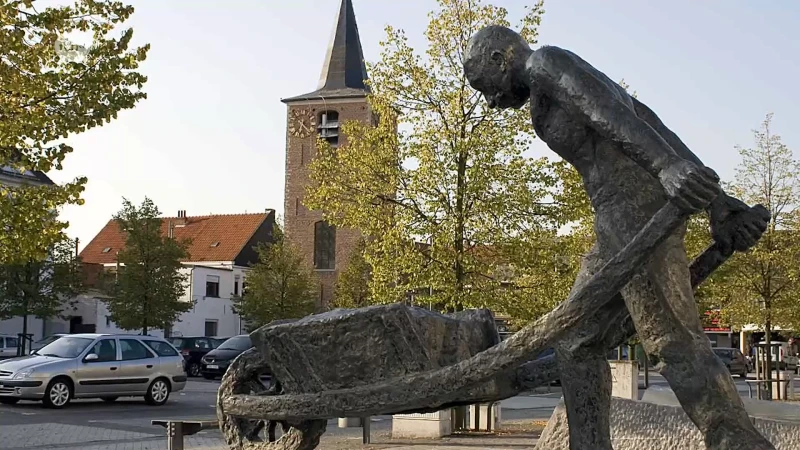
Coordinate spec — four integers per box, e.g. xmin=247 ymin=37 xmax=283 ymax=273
xmin=281 ymin=0 xmax=369 ymax=103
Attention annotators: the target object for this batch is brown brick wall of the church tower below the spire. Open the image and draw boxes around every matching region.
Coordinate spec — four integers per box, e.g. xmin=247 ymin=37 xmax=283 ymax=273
xmin=283 ymin=99 xmax=370 ymax=307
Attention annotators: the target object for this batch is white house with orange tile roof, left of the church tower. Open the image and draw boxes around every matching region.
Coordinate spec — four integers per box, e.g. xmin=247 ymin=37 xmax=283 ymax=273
xmin=73 ymin=210 xmax=275 ymax=337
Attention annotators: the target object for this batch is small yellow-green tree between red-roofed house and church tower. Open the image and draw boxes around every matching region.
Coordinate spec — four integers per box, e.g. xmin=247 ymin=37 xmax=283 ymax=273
xmin=232 ymin=224 xmax=318 ymax=329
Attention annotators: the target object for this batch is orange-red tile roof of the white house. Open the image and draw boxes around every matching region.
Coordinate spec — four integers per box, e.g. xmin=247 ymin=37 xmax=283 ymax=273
xmin=80 ymin=210 xmax=274 ymax=264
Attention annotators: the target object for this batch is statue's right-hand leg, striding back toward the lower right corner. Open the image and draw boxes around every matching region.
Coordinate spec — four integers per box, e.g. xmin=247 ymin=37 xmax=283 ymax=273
xmin=622 ymin=233 xmax=774 ymax=450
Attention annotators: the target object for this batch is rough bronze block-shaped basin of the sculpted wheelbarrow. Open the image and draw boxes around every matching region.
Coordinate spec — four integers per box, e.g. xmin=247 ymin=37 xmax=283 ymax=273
xmin=250 ymin=303 xmax=500 ymax=393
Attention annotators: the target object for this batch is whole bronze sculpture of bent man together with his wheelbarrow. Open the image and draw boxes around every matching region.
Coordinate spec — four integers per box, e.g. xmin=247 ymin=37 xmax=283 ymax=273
xmin=217 ymin=26 xmax=774 ymax=450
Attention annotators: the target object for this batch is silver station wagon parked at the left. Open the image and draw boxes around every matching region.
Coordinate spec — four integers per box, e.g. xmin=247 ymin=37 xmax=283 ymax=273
xmin=0 ymin=334 xmax=186 ymax=408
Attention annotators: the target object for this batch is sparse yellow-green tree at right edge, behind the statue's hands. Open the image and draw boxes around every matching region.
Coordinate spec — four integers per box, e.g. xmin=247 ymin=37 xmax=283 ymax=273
xmin=714 ymin=114 xmax=800 ymax=378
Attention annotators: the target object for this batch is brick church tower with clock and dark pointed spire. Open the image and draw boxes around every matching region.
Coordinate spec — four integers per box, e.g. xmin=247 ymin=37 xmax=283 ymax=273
xmin=281 ymin=0 xmax=371 ymax=306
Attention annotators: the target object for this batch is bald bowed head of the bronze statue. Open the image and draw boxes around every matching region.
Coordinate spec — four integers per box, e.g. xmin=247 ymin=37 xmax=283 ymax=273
xmin=464 ymin=25 xmax=532 ymax=109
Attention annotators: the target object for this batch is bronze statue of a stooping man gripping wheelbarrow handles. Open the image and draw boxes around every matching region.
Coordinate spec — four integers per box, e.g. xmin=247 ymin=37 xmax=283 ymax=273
xmin=464 ymin=26 xmax=774 ymax=450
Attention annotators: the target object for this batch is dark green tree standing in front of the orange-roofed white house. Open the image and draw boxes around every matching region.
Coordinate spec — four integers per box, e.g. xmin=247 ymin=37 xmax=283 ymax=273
xmin=106 ymin=197 xmax=194 ymax=334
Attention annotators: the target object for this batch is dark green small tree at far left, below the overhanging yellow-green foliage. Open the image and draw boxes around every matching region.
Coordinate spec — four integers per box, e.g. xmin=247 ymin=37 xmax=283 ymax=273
xmin=0 ymin=239 xmax=82 ymax=351
